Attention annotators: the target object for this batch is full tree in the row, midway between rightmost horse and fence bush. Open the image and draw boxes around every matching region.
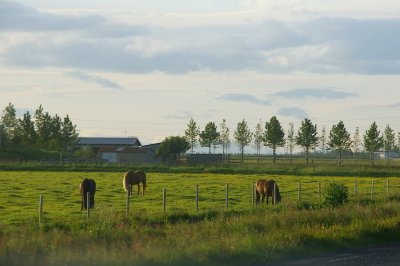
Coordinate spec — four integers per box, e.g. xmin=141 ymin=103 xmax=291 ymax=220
xmin=296 ymin=118 xmax=318 ymax=164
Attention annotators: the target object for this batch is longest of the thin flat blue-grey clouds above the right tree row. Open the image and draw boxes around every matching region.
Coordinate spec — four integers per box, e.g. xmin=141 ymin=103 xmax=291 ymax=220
xmin=271 ymin=89 xmax=358 ymax=99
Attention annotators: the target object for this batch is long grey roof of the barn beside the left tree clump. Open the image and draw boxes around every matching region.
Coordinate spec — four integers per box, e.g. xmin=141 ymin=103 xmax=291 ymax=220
xmin=74 ymin=137 xmax=142 ymax=152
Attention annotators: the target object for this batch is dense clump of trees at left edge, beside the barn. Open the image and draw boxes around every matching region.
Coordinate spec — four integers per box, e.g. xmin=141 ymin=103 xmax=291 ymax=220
xmin=0 ymin=103 xmax=78 ymax=152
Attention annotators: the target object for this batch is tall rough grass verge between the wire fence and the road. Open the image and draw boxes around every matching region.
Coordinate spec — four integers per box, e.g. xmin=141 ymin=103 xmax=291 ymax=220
xmin=0 ymin=197 xmax=400 ymax=265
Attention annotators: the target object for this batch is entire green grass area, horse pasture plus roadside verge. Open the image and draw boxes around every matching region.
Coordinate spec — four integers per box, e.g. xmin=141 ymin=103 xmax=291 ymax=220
xmin=0 ymin=171 xmax=400 ymax=266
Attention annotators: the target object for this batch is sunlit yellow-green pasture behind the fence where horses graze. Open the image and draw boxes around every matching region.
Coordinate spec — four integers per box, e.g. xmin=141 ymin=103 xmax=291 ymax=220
xmin=0 ymin=171 xmax=400 ymax=225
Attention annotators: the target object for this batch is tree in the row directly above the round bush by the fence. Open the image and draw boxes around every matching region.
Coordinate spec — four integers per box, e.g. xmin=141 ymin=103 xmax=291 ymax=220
xmin=328 ymin=121 xmax=351 ymax=165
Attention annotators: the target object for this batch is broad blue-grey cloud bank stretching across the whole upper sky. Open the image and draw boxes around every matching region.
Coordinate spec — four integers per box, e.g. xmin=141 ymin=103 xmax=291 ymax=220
xmin=0 ymin=0 xmax=400 ymax=75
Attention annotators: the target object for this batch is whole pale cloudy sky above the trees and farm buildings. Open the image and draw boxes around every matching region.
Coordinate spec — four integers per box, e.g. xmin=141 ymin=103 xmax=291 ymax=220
xmin=0 ymin=0 xmax=400 ymax=148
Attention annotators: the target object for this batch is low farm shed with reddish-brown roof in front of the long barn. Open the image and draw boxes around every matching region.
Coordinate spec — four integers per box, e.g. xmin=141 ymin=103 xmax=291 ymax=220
xmin=98 ymin=147 xmax=157 ymax=164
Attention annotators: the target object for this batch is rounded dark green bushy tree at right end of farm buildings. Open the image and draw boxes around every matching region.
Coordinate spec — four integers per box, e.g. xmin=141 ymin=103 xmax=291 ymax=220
xmin=156 ymin=136 xmax=190 ymax=161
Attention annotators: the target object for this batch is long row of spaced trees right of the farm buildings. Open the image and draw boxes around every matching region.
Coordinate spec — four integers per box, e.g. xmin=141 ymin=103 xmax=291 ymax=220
xmin=185 ymin=116 xmax=400 ymax=164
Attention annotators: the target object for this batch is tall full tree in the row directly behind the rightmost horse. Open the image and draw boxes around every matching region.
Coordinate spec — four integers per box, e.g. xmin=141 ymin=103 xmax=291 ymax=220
xmin=264 ymin=116 xmax=285 ymax=163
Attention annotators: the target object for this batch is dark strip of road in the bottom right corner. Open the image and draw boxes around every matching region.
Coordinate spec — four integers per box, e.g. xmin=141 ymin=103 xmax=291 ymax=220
xmin=268 ymin=243 xmax=400 ymax=266
